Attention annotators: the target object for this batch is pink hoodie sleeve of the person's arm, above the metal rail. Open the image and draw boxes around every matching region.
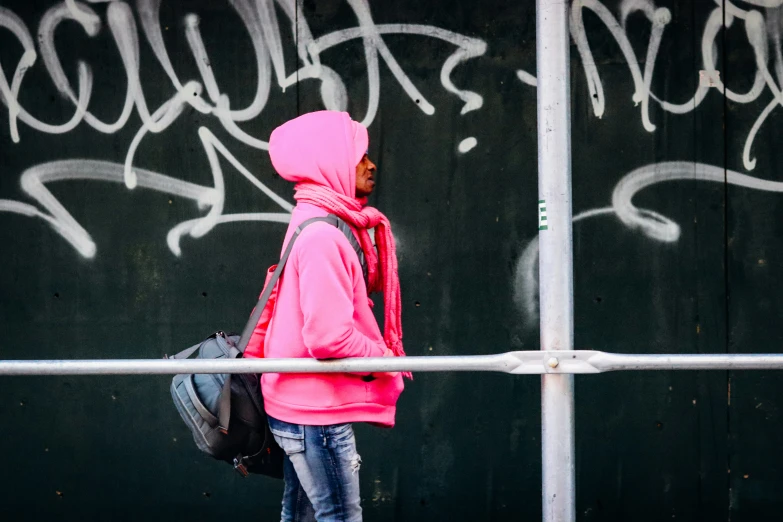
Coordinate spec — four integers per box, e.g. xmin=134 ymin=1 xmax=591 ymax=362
xmin=296 ymin=224 xmax=385 ymax=359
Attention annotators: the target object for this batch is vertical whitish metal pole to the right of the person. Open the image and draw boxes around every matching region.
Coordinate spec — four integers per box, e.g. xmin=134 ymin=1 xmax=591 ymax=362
xmin=536 ymin=0 xmax=576 ymax=522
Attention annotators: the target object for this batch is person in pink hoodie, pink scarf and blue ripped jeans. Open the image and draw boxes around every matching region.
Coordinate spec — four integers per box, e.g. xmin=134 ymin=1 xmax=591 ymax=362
xmin=261 ymin=111 xmax=409 ymax=522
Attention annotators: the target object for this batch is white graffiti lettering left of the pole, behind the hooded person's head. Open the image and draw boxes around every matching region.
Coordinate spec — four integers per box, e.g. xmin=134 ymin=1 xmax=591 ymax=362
xmin=0 ymin=0 xmax=486 ymax=258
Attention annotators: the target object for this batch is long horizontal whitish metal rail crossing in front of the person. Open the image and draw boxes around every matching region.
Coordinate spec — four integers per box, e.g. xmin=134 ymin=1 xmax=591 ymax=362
xmin=0 ymin=350 xmax=783 ymax=375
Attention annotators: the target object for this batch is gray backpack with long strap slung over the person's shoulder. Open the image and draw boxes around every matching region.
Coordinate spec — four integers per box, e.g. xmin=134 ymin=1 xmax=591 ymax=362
xmin=170 ymin=214 xmax=367 ymax=478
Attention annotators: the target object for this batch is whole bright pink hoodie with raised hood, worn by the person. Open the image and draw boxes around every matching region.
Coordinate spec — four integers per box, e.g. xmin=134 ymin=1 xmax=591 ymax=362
xmin=261 ymin=111 xmax=403 ymax=426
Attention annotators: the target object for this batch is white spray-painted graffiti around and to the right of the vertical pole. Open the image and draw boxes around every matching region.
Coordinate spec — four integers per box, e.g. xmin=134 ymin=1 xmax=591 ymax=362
xmin=513 ymin=0 xmax=783 ymax=328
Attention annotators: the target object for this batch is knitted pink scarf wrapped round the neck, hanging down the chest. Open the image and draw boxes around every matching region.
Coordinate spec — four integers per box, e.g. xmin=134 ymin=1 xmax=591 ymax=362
xmin=294 ymin=182 xmax=410 ymax=360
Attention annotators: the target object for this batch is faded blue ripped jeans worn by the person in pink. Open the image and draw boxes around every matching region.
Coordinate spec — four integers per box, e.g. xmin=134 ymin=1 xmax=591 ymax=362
xmin=268 ymin=417 xmax=362 ymax=522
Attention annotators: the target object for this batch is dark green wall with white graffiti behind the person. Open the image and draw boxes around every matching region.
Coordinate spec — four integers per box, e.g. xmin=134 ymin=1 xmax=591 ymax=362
xmin=0 ymin=0 xmax=783 ymax=522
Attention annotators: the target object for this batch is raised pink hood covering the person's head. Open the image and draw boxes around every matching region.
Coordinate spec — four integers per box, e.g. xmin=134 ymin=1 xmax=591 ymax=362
xmin=269 ymin=111 xmax=369 ymax=197
